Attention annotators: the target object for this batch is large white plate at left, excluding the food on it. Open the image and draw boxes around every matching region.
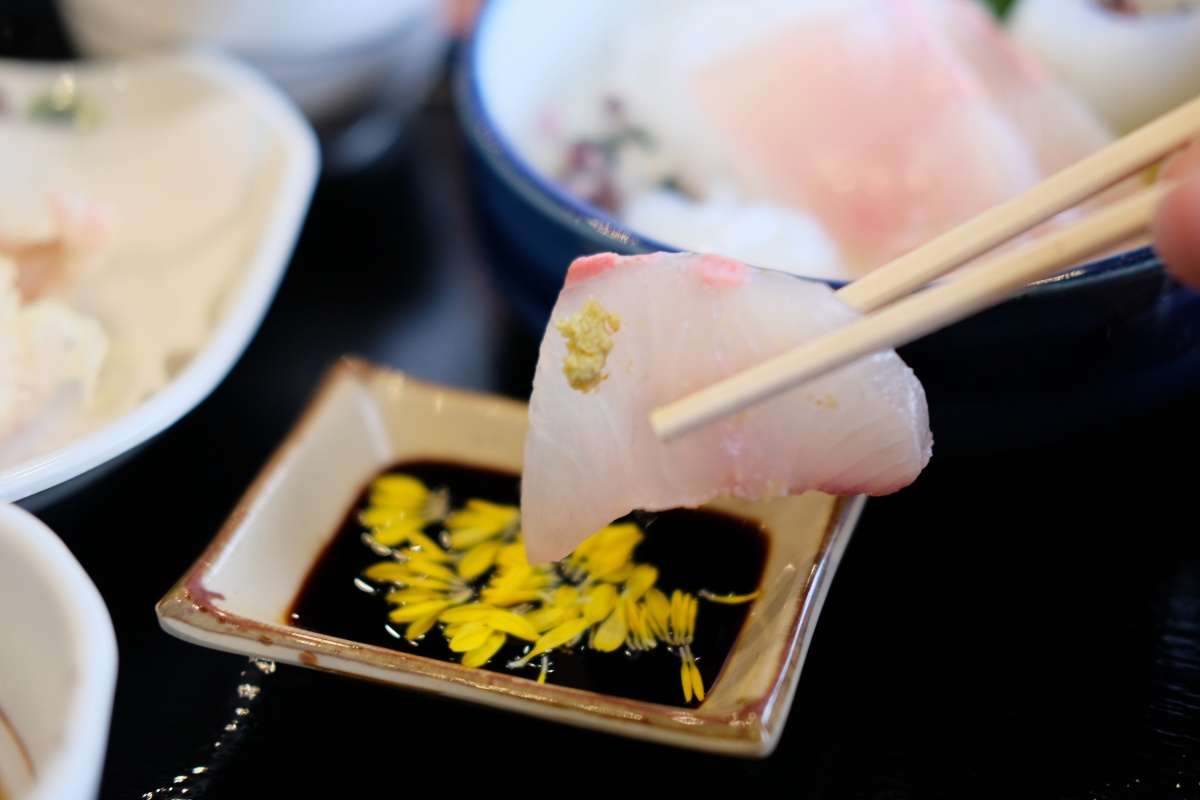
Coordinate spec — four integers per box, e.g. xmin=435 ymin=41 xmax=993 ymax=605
xmin=0 ymin=48 xmax=319 ymax=505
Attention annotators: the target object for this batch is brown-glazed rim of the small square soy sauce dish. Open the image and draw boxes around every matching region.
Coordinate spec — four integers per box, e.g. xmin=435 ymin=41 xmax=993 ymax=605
xmin=155 ymin=356 xmax=866 ymax=758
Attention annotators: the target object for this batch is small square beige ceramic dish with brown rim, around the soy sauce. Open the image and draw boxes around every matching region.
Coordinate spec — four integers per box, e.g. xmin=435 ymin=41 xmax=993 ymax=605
xmin=157 ymin=359 xmax=865 ymax=757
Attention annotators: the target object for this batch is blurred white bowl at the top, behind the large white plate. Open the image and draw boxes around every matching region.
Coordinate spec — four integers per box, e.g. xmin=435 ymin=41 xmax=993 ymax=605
xmin=59 ymin=0 xmax=450 ymax=167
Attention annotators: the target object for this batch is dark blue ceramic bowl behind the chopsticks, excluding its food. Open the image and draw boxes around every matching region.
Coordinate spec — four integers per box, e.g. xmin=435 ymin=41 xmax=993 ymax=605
xmin=455 ymin=0 xmax=1200 ymax=452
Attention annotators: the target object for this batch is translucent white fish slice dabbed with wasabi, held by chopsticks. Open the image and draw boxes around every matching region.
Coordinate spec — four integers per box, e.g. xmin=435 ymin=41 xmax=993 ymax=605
xmin=521 ymin=253 xmax=932 ymax=563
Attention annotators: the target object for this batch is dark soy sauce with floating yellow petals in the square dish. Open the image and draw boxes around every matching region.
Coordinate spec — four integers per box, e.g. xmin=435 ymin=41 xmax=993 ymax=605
xmin=289 ymin=461 xmax=767 ymax=708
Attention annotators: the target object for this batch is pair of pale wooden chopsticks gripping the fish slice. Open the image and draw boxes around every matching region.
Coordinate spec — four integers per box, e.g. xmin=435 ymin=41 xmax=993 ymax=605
xmin=650 ymin=97 xmax=1200 ymax=441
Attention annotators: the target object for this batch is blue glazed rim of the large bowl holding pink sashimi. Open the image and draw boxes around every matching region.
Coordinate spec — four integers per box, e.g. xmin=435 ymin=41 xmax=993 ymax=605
xmin=452 ymin=0 xmax=1165 ymax=297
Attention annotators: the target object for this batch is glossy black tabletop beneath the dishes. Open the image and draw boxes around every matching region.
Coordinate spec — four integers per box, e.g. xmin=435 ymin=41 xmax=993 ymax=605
xmin=0 ymin=0 xmax=1200 ymax=800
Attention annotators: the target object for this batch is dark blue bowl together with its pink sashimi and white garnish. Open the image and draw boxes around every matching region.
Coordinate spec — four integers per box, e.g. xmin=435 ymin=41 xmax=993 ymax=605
xmin=457 ymin=0 xmax=1200 ymax=450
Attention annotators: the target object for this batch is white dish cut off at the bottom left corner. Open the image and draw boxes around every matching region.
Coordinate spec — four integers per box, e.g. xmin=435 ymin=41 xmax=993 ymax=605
xmin=0 ymin=504 xmax=116 ymax=800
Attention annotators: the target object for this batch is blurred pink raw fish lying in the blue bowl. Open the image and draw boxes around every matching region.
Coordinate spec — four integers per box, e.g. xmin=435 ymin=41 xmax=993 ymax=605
xmin=692 ymin=0 xmax=1108 ymax=275
